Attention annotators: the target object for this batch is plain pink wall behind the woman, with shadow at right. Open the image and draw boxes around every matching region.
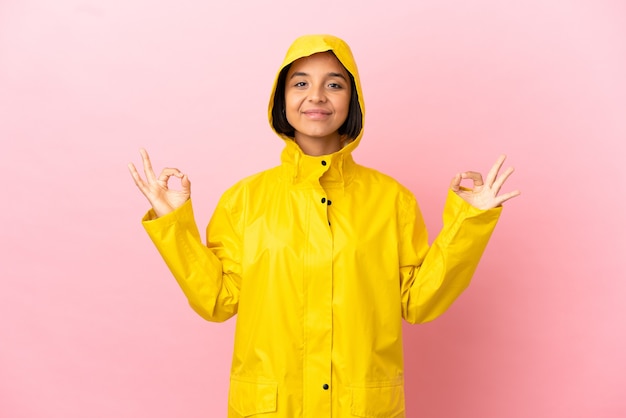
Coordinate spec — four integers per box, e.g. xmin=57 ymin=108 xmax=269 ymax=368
xmin=0 ymin=0 xmax=626 ymax=418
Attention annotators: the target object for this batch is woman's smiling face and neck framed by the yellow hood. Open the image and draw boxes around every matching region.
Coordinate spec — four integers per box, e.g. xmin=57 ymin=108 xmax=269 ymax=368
xmin=285 ymin=52 xmax=351 ymax=152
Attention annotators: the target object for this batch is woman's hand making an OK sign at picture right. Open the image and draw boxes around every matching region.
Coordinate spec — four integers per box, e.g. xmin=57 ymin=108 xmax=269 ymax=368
xmin=450 ymin=155 xmax=521 ymax=209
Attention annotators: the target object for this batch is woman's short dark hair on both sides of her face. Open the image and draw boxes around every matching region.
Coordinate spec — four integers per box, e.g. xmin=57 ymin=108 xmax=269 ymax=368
xmin=272 ymin=57 xmax=363 ymax=140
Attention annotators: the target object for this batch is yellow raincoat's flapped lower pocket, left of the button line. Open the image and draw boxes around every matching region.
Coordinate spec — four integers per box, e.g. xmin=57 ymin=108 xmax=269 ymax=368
xmin=228 ymin=377 xmax=278 ymax=417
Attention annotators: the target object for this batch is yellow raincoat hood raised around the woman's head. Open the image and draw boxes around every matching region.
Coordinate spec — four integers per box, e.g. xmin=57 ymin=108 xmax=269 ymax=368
xmin=268 ymin=35 xmax=365 ymax=158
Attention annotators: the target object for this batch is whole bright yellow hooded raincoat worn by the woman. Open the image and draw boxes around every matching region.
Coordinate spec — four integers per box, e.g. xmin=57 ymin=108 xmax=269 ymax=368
xmin=143 ymin=35 xmax=501 ymax=418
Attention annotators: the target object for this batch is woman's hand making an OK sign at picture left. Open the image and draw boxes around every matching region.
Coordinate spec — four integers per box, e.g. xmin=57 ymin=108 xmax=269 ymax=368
xmin=128 ymin=148 xmax=191 ymax=217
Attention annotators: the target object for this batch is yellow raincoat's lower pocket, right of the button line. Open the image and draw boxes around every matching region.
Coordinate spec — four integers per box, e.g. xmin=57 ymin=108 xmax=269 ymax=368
xmin=350 ymin=382 xmax=404 ymax=418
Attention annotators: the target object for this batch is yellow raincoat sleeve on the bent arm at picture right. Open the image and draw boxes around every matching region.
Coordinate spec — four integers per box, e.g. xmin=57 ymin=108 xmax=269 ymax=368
xmin=399 ymin=191 xmax=502 ymax=324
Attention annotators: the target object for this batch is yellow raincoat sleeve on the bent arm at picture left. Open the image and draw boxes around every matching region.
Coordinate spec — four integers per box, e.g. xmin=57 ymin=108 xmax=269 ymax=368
xmin=142 ymin=193 xmax=241 ymax=322
